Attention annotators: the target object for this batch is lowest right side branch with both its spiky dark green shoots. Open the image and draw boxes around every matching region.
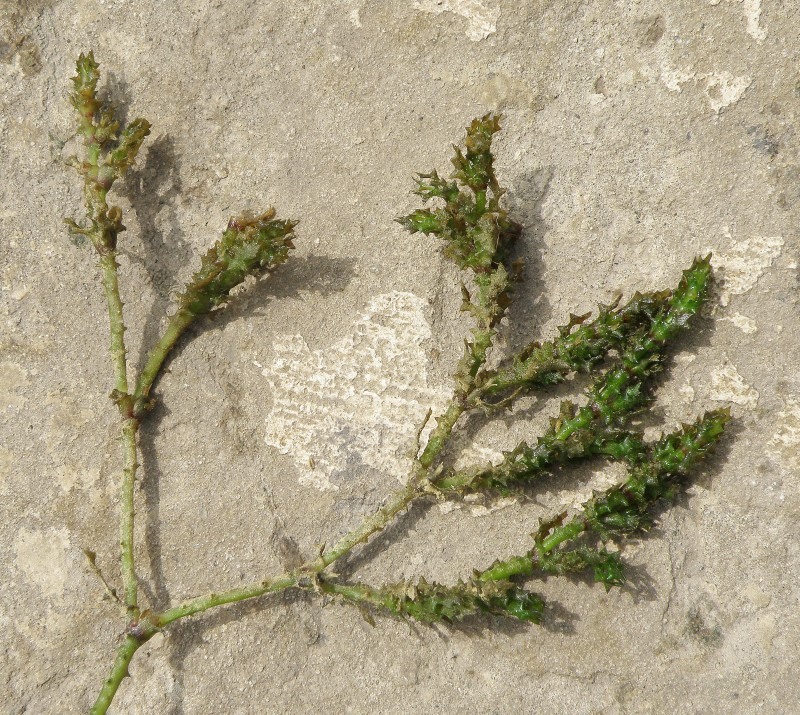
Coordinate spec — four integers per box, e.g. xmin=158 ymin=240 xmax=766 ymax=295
xmin=328 ymin=409 xmax=730 ymax=623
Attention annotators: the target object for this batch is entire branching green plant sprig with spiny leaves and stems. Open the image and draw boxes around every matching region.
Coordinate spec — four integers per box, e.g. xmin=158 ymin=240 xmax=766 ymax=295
xmin=62 ymin=52 xmax=729 ymax=714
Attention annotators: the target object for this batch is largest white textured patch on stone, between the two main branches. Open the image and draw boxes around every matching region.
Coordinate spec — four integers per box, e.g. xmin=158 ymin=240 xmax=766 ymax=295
xmin=262 ymin=291 xmax=451 ymax=490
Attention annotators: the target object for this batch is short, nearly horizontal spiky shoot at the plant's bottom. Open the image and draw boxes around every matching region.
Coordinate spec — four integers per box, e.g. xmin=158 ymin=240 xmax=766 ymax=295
xmin=321 ymin=579 xmax=544 ymax=623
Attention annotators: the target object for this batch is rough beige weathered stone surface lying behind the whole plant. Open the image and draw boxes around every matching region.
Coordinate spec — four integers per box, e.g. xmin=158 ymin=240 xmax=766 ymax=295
xmin=0 ymin=0 xmax=800 ymax=715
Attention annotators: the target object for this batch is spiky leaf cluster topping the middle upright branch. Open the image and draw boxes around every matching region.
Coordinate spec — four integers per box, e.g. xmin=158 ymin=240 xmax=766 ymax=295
xmin=397 ymin=114 xmax=521 ymax=274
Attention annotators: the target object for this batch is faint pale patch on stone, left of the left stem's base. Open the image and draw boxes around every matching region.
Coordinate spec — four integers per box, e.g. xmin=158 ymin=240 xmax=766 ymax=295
xmin=14 ymin=528 xmax=72 ymax=597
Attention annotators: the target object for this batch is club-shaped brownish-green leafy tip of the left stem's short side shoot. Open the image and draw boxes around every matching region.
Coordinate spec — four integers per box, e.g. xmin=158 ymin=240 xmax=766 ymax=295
xmin=178 ymin=209 xmax=297 ymax=315
